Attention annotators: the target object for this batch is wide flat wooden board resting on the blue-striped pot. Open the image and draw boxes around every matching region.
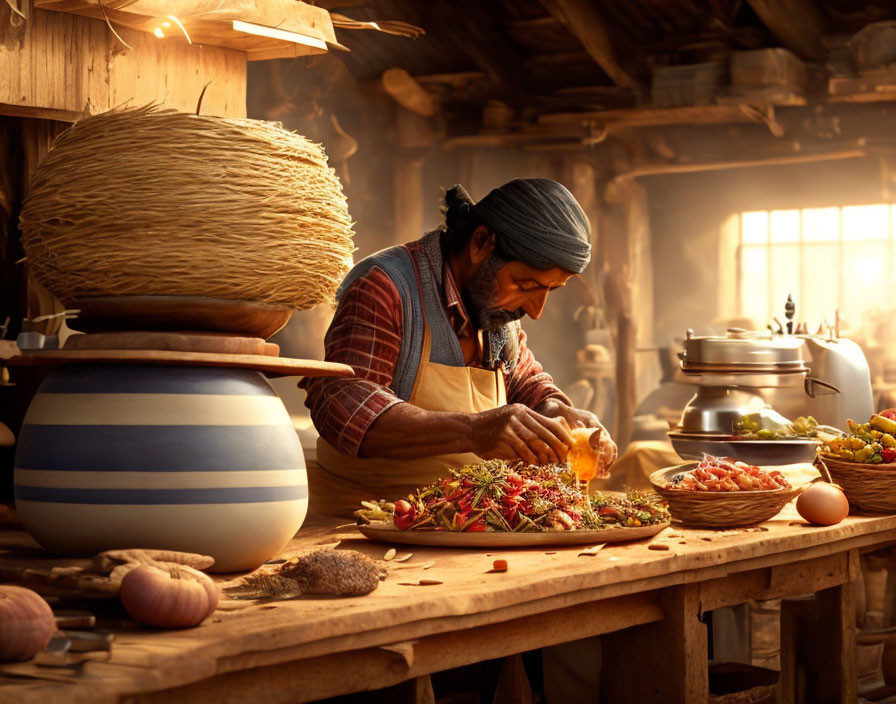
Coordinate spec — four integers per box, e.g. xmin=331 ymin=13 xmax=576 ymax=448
xmin=5 ymin=350 xmax=355 ymax=377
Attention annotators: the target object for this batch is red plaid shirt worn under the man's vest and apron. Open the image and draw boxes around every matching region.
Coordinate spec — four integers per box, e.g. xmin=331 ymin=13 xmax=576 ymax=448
xmin=299 ymin=258 xmax=569 ymax=457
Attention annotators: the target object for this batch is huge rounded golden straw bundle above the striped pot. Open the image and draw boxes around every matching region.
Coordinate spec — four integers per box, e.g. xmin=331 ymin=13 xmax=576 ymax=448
xmin=21 ymin=106 xmax=353 ymax=310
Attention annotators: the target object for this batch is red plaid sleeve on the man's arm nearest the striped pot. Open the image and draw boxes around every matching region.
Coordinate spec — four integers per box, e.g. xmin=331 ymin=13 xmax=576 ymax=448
xmin=299 ymin=267 xmax=402 ymax=457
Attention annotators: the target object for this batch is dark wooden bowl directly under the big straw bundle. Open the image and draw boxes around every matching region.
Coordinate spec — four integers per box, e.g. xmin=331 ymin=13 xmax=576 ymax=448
xmin=66 ymin=296 xmax=292 ymax=340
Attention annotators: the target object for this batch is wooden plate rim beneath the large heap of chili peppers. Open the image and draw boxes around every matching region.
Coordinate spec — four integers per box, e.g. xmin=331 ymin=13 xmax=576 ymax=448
xmin=358 ymin=522 xmax=669 ymax=548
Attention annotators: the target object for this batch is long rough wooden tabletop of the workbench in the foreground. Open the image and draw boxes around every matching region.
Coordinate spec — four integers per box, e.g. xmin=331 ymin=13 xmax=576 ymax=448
xmin=0 ymin=505 xmax=896 ymax=704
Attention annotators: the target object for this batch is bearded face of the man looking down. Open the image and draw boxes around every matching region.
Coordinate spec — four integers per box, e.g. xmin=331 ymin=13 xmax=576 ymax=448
xmin=463 ymin=252 xmax=573 ymax=331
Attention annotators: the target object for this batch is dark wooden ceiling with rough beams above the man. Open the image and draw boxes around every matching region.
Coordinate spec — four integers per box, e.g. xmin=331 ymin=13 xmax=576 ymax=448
xmin=280 ymin=0 xmax=896 ymax=157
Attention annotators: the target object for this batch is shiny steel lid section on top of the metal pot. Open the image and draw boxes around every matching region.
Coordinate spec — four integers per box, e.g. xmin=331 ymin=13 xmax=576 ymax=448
xmin=680 ymin=328 xmax=808 ymax=374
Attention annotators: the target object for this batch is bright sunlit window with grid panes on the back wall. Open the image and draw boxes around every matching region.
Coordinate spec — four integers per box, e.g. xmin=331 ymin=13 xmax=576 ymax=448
xmin=731 ymin=203 xmax=896 ymax=332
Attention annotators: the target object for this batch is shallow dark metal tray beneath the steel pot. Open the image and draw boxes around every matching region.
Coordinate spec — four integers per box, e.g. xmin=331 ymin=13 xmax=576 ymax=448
xmin=669 ymin=432 xmax=821 ymax=467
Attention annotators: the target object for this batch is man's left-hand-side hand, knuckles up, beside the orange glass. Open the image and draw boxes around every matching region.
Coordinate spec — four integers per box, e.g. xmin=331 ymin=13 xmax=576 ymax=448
xmin=473 ymin=403 xmax=572 ymax=465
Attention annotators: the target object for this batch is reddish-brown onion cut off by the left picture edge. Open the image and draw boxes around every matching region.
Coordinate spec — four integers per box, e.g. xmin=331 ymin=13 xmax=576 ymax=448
xmin=0 ymin=584 xmax=56 ymax=662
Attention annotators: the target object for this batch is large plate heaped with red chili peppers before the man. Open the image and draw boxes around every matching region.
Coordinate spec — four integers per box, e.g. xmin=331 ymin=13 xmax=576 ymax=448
xmin=355 ymin=460 xmax=670 ymax=547
